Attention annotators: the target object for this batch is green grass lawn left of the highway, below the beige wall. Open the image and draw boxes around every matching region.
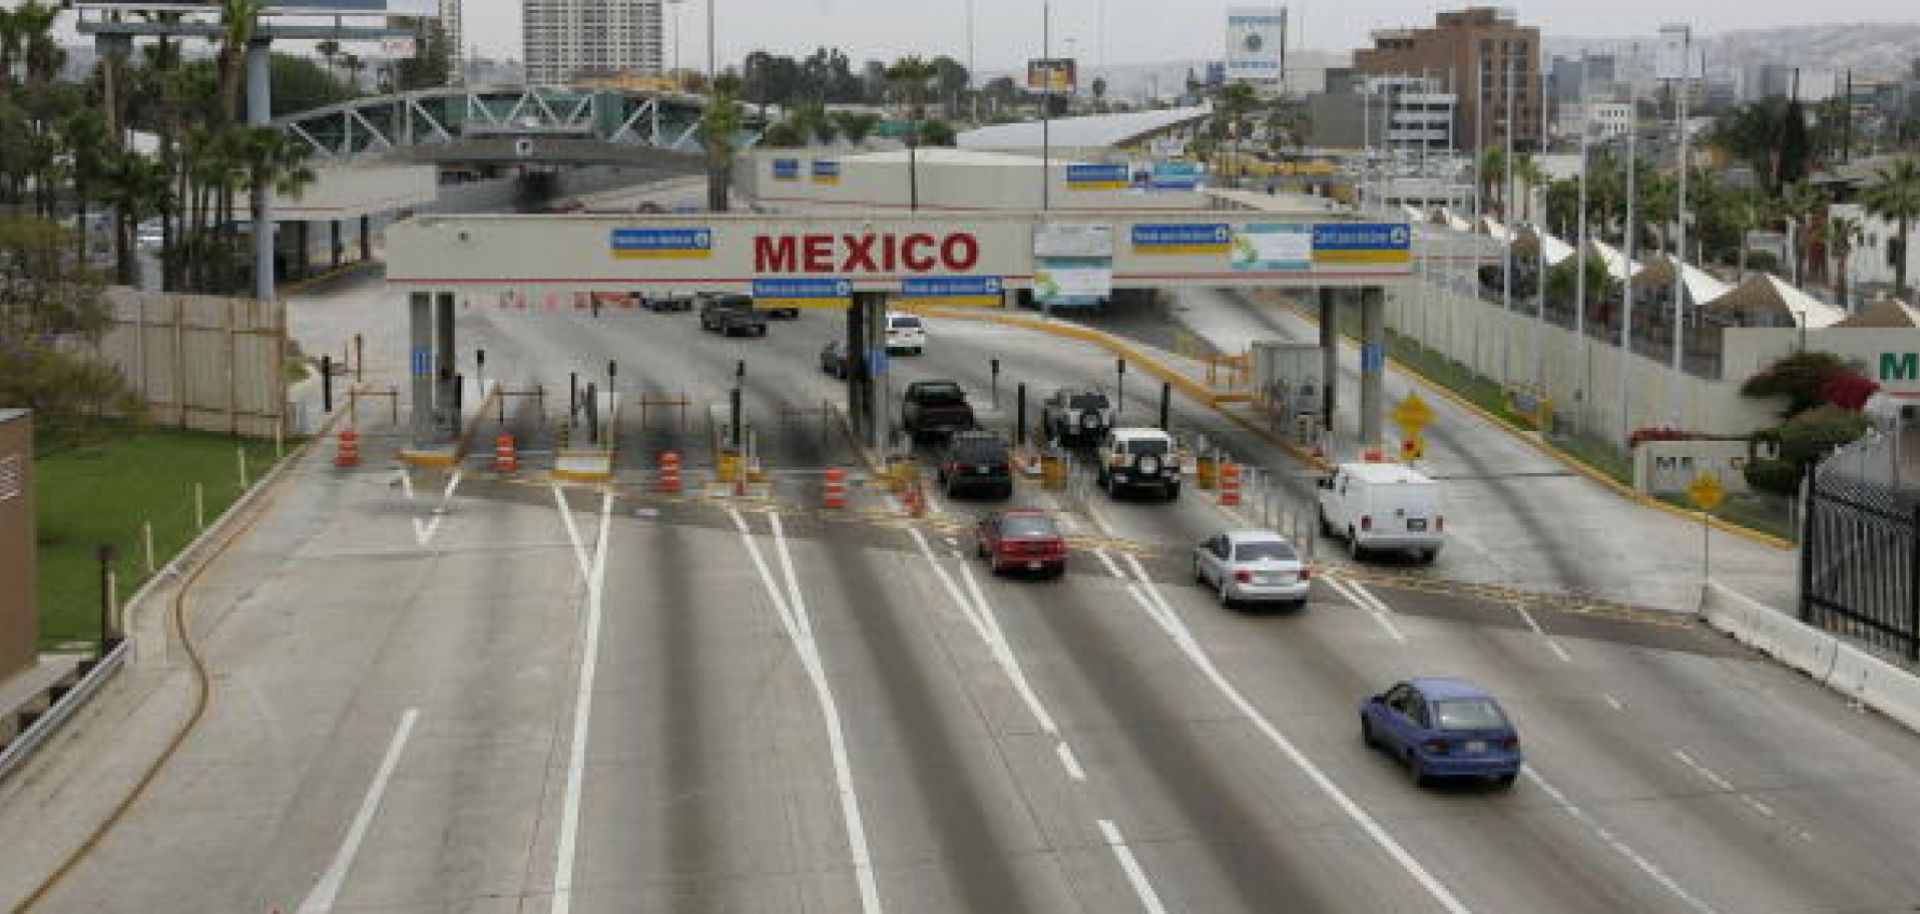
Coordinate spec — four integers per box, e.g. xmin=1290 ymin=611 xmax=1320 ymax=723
xmin=36 ymin=430 xmax=294 ymax=651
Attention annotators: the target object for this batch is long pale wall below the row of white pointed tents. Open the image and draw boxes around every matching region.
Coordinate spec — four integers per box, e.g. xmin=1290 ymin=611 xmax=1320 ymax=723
xmin=1386 ymin=274 xmax=1774 ymax=440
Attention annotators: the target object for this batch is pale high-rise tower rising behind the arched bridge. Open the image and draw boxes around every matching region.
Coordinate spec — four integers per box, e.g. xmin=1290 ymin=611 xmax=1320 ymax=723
xmin=520 ymin=0 xmax=664 ymax=84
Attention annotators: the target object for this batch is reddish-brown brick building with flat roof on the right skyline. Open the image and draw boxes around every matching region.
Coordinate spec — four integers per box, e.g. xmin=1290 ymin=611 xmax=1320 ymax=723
xmin=1354 ymin=6 xmax=1546 ymax=150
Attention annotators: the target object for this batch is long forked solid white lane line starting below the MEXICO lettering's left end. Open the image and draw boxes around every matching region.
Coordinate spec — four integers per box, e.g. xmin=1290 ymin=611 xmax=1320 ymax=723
xmin=728 ymin=507 xmax=881 ymax=914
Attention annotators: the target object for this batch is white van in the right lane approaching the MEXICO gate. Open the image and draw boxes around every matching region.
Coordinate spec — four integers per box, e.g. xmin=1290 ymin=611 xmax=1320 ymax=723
xmin=1319 ymin=463 xmax=1446 ymax=563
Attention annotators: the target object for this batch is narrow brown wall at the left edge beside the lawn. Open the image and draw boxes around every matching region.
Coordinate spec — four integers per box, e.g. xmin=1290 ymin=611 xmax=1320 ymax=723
xmin=0 ymin=409 xmax=40 ymax=682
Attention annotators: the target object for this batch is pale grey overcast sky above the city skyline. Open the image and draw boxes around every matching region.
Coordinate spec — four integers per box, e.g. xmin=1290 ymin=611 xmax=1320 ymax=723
xmin=456 ymin=0 xmax=1920 ymax=69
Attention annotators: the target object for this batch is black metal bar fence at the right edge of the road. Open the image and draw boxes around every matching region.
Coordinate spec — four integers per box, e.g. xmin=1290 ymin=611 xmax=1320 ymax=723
xmin=1801 ymin=434 xmax=1920 ymax=661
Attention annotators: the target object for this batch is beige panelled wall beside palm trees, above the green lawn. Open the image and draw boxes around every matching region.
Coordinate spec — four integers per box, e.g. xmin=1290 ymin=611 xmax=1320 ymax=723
xmin=98 ymin=286 xmax=286 ymax=438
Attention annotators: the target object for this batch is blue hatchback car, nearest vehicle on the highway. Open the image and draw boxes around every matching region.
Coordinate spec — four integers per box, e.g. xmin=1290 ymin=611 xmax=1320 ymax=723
xmin=1359 ymin=678 xmax=1521 ymax=787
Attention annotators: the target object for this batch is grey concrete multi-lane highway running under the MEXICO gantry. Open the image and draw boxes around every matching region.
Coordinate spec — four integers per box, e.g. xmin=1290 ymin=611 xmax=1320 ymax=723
xmin=0 ymin=266 xmax=1920 ymax=914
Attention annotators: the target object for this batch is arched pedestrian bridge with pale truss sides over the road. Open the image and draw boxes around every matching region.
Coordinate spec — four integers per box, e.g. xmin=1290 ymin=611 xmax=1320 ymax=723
xmin=273 ymin=84 xmax=764 ymax=163
